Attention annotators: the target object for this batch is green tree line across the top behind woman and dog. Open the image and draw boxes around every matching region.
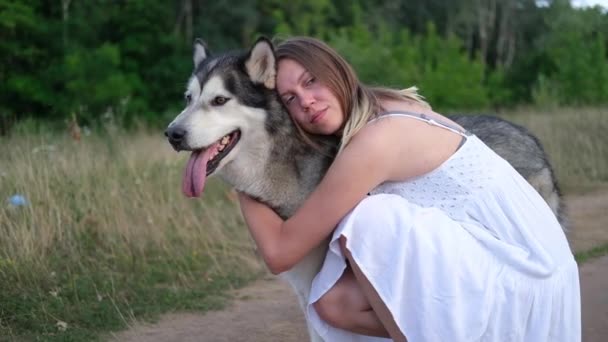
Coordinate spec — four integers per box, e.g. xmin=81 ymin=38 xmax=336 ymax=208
xmin=0 ymin=0 xmax=608 ymax=131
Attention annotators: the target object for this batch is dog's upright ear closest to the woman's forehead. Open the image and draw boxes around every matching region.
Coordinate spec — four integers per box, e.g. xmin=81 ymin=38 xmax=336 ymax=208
xmin=245 ymin=37 xmax=277 ymax=89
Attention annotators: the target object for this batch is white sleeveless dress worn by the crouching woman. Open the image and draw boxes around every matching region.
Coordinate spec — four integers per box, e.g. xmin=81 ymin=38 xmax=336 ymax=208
xmin=306 ymin=114 xmax=581 ymax=342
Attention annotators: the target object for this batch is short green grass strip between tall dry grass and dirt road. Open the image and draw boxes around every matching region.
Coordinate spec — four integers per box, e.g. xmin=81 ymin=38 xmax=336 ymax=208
xmin=0 ymin=253 xmax=252 ymax=341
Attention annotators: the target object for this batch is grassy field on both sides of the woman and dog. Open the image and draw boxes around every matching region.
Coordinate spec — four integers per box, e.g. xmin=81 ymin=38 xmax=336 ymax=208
xmin=0 ymin=109 xmax=608 ymax=341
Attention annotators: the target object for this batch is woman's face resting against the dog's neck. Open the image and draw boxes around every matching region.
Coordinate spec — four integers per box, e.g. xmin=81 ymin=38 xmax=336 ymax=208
xmin=277 ymin=58 xmax=344 ymax=135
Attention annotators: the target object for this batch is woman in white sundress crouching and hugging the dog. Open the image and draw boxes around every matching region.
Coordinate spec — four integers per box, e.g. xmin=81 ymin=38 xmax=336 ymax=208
xmin=239 ymin=37 xmax=580 ymax=342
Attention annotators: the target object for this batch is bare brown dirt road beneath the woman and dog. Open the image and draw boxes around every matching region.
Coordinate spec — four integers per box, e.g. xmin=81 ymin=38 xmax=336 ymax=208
xmin=110 ymin=190 xmax=608 ymax=342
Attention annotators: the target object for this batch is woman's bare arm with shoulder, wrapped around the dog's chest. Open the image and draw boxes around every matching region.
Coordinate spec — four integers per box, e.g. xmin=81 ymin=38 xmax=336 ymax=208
xmin=239 ymin=119 xmax=457 ymax=274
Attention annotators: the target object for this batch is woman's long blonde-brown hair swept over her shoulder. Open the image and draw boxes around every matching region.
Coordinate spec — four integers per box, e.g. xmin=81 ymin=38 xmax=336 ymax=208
xmin=275 ymin=37 xmax=429 ymax=153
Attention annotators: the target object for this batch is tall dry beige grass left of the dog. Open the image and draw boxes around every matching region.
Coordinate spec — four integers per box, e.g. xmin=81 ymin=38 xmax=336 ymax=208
xmin=0 ymin=128 xmax=258 ymax=272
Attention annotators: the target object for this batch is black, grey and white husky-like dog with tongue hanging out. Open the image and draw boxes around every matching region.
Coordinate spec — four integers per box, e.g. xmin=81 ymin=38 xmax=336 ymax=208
xmin=165 ymin=38 xmax=563 ymax=341
